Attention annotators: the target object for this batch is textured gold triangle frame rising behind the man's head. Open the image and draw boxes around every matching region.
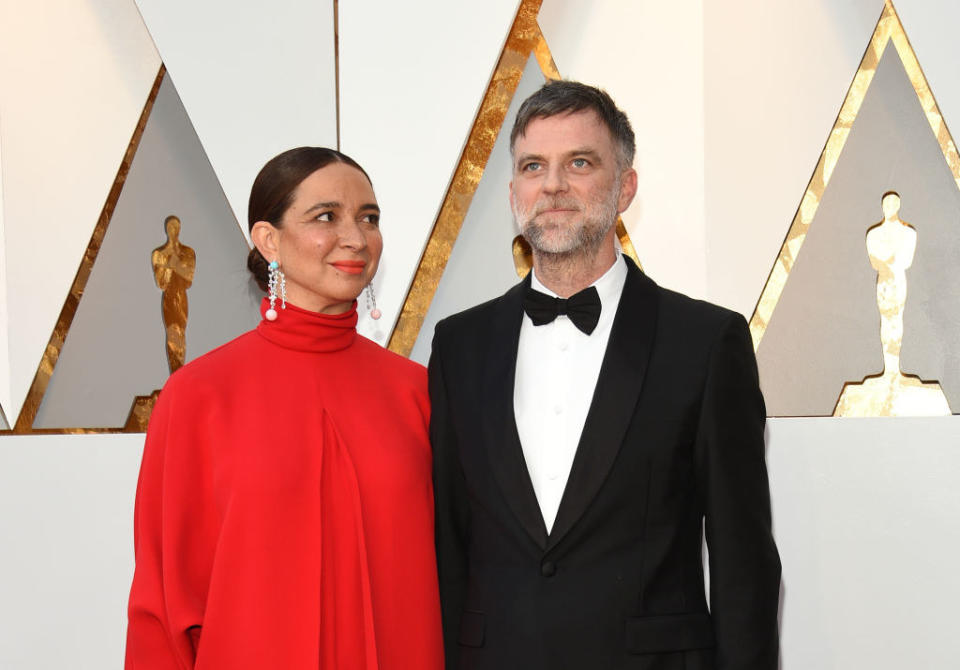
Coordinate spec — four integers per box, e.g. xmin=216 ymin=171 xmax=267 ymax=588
xmin=387 ymin=0 xmax=640 ymax=356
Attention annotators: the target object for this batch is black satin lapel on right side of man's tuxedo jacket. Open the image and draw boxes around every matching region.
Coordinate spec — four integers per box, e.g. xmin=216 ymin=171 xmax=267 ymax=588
xmin=547 ymin=261 xmax=657 ymax=550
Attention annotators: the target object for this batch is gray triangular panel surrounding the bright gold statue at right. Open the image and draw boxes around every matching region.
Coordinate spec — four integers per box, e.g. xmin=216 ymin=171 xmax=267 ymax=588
xmin=756 ymin=43 xmax=960 ymax=416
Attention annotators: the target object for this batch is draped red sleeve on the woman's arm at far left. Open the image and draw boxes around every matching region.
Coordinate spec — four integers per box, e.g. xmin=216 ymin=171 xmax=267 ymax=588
xmin=125 ymin=377 xmax=217 ymax=670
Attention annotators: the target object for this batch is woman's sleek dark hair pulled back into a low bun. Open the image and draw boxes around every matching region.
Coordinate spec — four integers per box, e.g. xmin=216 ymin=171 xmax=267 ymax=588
xmin=247 ymin=147 xmax=373 ymax=291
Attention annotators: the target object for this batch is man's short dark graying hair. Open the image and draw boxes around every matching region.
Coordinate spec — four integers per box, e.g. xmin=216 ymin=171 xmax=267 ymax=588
xmin=510 ymin=80 xmax=637 ymax=169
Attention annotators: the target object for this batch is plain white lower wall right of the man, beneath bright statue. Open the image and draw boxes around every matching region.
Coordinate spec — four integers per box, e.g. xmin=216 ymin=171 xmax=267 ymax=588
xmin=767 ymin=417 xmax=960 ymax=670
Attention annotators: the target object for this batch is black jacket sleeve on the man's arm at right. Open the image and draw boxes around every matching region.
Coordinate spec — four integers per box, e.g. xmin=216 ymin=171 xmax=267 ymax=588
xmin=697 ymin=314 xmax=780 ymax=670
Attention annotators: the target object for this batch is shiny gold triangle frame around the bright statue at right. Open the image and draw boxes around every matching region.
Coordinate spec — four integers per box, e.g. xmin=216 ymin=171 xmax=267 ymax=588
xmin=750 ymin=0 xmax=960 ymax=350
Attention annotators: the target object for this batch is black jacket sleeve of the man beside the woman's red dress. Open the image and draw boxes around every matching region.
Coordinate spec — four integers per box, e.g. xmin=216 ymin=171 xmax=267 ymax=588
xmin=429 ymin=323 xmax=470 ymax=668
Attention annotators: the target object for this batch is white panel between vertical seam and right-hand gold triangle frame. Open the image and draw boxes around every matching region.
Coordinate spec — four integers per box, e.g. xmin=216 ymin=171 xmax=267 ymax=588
xmin=703 ymin=0 xmax=883 ymax=317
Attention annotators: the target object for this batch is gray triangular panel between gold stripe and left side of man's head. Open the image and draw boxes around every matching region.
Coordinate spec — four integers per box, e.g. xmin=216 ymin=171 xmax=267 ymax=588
xmin=410 ymin=57 xmax=546 ymax=364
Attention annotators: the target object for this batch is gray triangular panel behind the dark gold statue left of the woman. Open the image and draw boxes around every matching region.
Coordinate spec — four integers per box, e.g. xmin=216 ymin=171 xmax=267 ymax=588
xmin=34 ymin=76 xmax=261 ymax=428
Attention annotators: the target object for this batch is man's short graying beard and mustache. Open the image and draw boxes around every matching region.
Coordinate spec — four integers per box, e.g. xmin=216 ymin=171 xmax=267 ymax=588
xmin=513 ymin=182 xmax=620 ymax=256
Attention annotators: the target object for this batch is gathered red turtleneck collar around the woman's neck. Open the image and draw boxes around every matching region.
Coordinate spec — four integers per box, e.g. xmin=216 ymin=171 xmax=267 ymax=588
xmin=257 ymin=298 xmax=357 ymax=352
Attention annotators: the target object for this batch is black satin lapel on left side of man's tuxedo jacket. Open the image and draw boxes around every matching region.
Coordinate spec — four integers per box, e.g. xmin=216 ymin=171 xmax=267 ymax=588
xmin=482 ymin=276 xmax=547 ymax=548
